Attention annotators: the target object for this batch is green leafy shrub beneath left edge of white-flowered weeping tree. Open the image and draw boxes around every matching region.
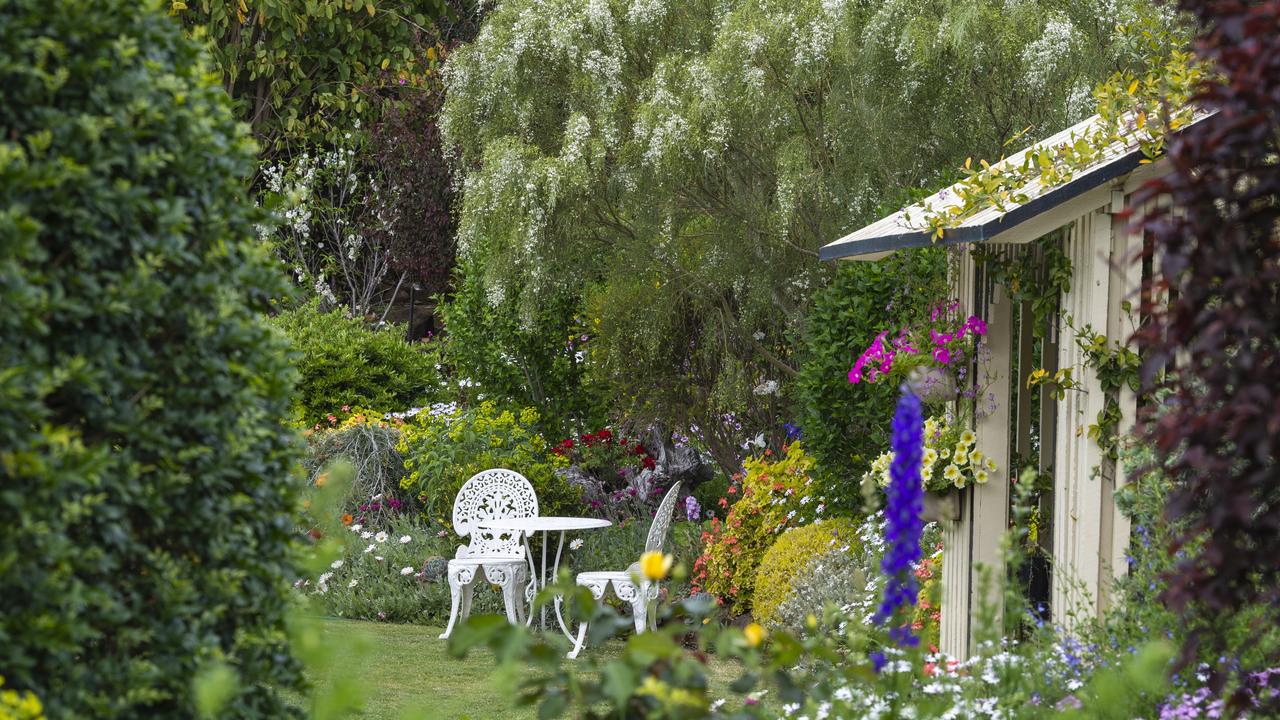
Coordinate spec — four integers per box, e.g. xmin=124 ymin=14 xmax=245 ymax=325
xmin=436 ymin=260 xmax=604 ymax=437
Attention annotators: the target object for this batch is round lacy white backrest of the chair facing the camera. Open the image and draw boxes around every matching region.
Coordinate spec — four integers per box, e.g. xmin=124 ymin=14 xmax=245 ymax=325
xmin=453 ymin=468 xmax=538 ymax=557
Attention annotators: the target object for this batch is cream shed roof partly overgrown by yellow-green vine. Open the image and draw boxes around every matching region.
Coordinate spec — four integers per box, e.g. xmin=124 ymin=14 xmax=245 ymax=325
xmin=818 ymin=111 xmax=1208 ymax=260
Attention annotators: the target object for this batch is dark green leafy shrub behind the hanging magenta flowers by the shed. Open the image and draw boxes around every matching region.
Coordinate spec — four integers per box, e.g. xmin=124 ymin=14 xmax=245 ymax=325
xmin=797 ymin=251 xmax=947 ymax=510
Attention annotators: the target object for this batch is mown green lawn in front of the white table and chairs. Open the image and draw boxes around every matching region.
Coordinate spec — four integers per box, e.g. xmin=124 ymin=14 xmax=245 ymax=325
xmin=293 ymin=609 xmax=737 ymax=720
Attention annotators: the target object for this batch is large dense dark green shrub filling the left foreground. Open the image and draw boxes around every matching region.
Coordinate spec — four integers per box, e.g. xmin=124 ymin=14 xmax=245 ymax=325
xmin=0 ymin=0 xmax=301 ymax=719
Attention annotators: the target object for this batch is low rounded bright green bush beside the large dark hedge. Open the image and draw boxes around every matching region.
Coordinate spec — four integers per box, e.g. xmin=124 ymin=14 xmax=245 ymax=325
xmin=271 ymin=302 xmax=440 ymax=425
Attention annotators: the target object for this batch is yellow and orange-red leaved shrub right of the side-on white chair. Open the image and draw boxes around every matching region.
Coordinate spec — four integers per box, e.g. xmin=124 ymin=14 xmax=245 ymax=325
xmin=692 ymin=442 xmax=826 ymax=612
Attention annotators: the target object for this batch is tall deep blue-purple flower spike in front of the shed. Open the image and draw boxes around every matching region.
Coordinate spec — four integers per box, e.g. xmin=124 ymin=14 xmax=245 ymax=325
xmin=876 ymin=387 xmax=924 ymax=647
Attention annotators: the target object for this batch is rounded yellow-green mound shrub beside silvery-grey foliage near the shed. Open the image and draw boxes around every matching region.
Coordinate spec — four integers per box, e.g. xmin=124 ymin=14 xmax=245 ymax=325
xmin=751 ymin=518 xmax=858 ymax=626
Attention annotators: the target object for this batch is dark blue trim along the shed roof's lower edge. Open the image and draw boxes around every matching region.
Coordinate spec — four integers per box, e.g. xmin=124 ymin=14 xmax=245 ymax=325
xmin=818 ymin=143 xmax=1143 ymax=260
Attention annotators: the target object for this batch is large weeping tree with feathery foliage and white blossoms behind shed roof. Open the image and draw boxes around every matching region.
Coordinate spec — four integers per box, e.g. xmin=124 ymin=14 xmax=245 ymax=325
xmin=442 ymin=0 xmax=1171 ymax=464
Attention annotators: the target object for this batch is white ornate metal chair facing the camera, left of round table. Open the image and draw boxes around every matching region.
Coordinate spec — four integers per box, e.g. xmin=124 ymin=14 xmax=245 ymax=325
xmin=440 ymin=469 xmax=538 ymax=639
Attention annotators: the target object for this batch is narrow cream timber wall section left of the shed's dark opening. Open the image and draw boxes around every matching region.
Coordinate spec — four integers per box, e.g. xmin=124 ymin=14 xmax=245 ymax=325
xmin=940 ymin=244 xmax=1015 ymax=657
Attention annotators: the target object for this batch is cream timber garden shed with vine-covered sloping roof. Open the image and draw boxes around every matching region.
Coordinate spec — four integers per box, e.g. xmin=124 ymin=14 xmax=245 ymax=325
xmin=820 ymin=113 xmax=1198 ymax=656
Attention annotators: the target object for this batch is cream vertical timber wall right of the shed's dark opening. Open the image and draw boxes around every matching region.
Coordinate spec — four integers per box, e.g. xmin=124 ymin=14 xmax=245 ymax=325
xmin=1052 ymin=206 xmax=1128 ymax=628
